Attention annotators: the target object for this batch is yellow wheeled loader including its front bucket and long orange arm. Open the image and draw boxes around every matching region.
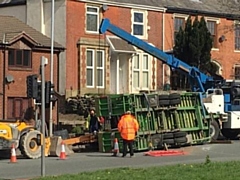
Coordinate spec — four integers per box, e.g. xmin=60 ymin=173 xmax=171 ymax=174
xmin=0 ymin=120 xmax=97 ymax=159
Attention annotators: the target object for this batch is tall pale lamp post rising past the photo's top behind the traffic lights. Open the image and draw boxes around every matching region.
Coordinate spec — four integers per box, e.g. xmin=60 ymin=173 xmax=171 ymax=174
xmin=49 ymin=0 xmax=55 ymax=137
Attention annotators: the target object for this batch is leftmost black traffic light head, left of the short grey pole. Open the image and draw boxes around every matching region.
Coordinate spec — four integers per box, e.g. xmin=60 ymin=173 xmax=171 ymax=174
xmin=27 ymin=75 xmax=38 ymax=99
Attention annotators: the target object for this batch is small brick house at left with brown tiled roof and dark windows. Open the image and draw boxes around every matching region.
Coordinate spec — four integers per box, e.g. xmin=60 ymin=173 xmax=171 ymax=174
xmin=0 ymin=16 xmax=64 ymax=124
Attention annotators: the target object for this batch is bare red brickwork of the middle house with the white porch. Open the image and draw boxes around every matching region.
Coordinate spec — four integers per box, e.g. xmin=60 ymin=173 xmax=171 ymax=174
xmin=66 ymin=1 xmax=165 ymax=91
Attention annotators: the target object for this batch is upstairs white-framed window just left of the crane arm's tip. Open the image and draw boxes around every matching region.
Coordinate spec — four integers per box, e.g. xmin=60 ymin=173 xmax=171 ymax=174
xmin=86 ymin=6 xmax=99 ymax=33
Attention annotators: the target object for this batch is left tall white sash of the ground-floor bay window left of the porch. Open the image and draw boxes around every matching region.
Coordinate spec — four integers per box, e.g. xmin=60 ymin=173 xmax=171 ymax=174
xmin=87 ymin=50 xmax=94 ymax=87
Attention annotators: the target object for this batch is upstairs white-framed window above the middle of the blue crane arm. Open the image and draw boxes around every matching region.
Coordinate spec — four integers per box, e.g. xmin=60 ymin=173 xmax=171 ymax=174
xmin=132 ymin=11 xmax=147 ymax=38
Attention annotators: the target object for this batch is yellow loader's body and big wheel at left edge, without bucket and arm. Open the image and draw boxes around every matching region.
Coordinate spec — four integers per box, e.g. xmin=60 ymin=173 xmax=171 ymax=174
xmin=0 ymin=120 xmax=51 ymax=159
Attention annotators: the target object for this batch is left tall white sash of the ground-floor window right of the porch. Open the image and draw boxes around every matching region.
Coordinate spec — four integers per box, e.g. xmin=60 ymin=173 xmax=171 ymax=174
xmin=133 ymin=55 xmax=140 ymax=88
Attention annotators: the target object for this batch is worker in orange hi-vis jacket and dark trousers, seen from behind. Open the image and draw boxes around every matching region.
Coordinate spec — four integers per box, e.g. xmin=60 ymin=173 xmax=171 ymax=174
xmin=118 ymin=111 xmax=139 ymax=157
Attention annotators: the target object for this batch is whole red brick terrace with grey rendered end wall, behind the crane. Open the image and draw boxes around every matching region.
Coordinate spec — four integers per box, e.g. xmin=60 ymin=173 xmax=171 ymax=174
xmin=0 ymin=0 xmax=240 ymax=96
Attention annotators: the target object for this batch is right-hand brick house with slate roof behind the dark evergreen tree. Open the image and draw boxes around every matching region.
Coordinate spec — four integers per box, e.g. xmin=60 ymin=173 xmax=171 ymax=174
xmin=161 ymin=0 xmax=240 ymax=86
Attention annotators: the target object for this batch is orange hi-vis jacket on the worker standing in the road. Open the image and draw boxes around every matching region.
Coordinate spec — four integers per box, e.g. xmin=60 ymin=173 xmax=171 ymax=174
xmin=118 ymin=114 xmax=139 ymax=140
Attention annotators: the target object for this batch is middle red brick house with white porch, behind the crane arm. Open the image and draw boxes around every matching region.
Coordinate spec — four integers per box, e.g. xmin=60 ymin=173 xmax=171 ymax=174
xmin=67 ymin=1 xmax=163 ymax=94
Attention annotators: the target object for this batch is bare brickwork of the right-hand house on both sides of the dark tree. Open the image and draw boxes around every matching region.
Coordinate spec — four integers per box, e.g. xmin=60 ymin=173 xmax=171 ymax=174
xmin=165 ymin=13 xmax=240 ymax=79
